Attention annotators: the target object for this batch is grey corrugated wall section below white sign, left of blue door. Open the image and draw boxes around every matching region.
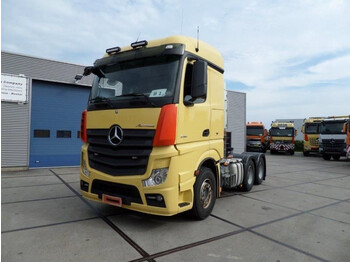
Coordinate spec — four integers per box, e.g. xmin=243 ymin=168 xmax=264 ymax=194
xmin=1 ymin=83 xmax=30 ymax=167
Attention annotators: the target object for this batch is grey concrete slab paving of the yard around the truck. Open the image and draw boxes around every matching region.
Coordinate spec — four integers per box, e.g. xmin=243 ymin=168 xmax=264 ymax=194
xmin=1 ymin=154 xmax=350 ymax=262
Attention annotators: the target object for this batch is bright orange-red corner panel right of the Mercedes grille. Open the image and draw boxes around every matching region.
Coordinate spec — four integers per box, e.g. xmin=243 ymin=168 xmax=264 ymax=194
xmin=153 ymin=104 xmax=177 ymax=146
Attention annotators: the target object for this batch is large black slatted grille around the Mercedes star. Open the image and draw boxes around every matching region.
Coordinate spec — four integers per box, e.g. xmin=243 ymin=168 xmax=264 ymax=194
xmin=87 ymin=129 xmax=155 ymax=176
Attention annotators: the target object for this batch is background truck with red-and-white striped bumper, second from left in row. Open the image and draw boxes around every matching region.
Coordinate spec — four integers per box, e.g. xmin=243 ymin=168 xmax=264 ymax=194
xmin=269 ymin=121 xmax=297 ymax=155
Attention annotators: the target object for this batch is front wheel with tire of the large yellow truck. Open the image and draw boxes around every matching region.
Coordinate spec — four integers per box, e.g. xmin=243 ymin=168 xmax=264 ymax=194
xmin=190 ymin=167 xmax=216 ymax=220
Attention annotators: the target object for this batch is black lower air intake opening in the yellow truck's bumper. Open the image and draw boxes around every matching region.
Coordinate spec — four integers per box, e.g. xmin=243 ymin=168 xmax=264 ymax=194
xmin=91 ymin=179 xmax=142 ymax=205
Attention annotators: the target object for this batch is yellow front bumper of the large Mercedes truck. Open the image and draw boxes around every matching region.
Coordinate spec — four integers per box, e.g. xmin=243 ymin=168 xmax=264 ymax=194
xmin=80 ymin=146 xmax=195 ymax=216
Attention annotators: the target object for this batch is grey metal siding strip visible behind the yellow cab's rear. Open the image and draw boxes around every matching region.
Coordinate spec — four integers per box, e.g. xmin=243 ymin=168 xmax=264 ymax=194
xmin=227 ymin=90 xmax=246 ymax=153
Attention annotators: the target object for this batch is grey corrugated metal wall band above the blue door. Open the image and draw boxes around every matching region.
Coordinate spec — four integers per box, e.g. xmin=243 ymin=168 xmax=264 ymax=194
xmin=1 ymin=52 xmax=93 ymax=86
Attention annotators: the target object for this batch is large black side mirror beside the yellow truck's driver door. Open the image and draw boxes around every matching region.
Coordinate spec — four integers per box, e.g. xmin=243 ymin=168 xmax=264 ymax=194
xmin=191 ymin=61 xmax=207 ymax=98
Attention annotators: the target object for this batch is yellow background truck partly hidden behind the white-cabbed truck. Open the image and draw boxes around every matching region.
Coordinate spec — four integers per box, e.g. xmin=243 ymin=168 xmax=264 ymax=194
xmin=301 ymin=117 xmax=324 ymax=156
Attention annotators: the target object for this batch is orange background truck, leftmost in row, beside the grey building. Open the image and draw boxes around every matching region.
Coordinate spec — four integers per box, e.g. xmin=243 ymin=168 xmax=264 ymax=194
xmin=246 ymin=122 xmax=268 ymax=153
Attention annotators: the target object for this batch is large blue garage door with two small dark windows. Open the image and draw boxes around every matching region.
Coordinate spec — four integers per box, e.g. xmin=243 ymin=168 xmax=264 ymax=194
xmin=29 ymin=81 xmax=90 ymax=167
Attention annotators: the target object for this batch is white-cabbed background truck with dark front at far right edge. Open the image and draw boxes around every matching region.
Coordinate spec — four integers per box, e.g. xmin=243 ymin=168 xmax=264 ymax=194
xmin=319 ymin=116 xmax=349 ymax=160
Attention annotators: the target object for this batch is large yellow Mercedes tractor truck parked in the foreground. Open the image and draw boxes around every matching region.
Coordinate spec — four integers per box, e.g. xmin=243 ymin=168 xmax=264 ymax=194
xmin=80 ymin=36 xmax=266 ymax=219
